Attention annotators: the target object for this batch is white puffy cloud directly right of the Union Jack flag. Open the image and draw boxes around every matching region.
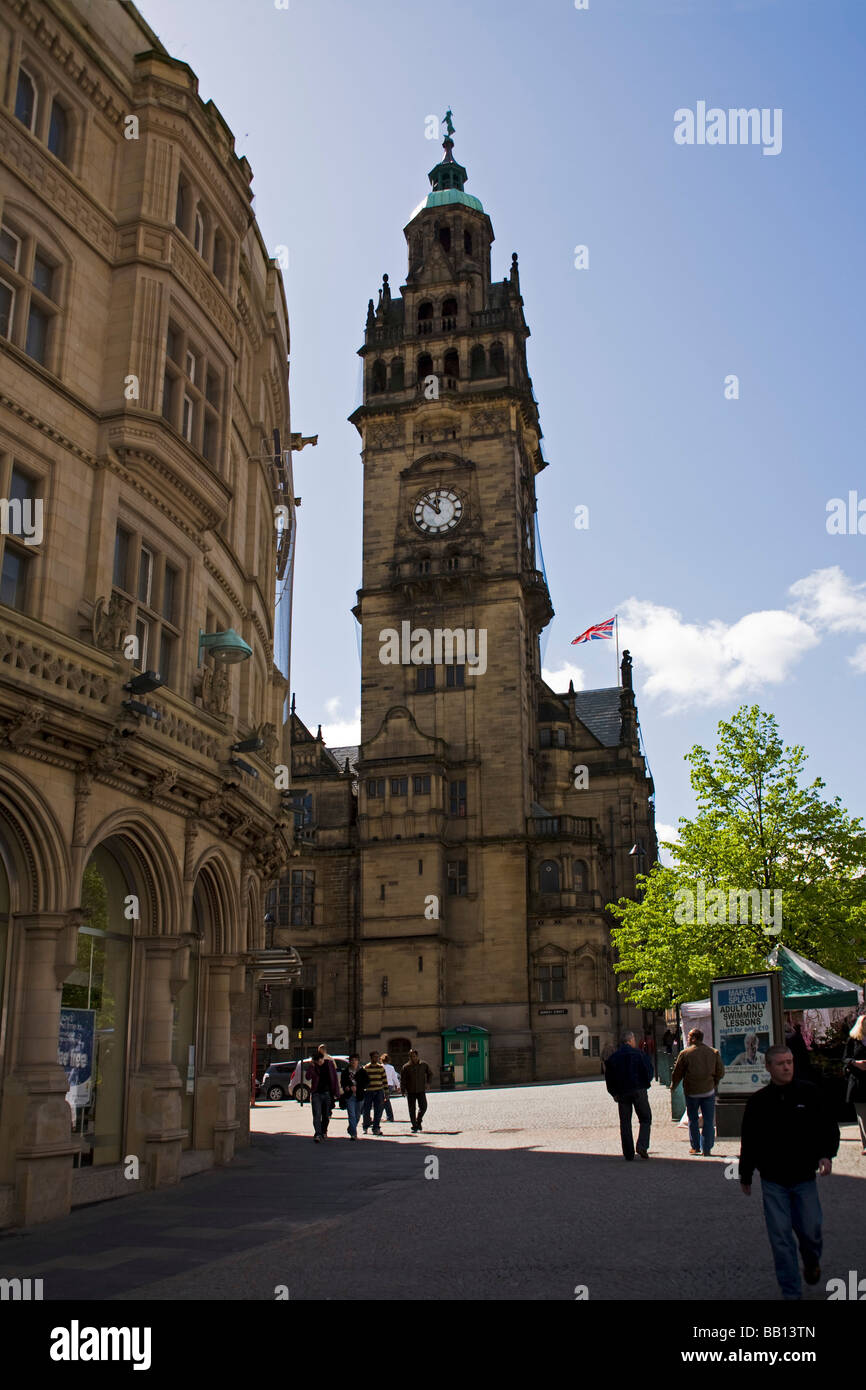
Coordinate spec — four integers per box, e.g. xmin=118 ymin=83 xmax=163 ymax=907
xmin=620 ymin=598 xmax=820 ymax=714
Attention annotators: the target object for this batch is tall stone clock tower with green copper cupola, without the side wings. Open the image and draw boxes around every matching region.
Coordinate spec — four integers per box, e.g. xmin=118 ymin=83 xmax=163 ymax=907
xmin=352 ymin=113 xmax=566 ymax=1081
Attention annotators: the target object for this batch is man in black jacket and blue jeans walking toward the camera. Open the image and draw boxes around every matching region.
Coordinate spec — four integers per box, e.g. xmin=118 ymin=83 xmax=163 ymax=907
xmin=740 ymin=1043 xmax=840 ymax=1301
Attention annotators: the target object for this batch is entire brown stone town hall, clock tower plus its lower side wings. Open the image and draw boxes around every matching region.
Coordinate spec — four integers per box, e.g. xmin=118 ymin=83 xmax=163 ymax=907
xmin=281 ymin=126 xmax=656 ymax=1081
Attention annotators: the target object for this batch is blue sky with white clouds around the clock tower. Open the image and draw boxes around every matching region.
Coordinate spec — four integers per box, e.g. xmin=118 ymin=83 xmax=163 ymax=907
xmin=140 ymin=0 xmax=866 ymax=838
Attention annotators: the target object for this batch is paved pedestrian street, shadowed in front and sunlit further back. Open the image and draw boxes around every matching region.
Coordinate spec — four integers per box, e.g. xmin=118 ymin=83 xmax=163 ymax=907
xmin=0 ymin=1080 xmax=866 ymax=1301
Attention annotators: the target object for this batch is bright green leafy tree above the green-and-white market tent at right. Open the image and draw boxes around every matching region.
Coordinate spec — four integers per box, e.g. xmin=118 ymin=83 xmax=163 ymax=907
xmin=609 ymin=705 xmax=866 ymax=1009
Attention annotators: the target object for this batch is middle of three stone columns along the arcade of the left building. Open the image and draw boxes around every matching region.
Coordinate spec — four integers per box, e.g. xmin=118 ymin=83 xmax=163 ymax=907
xmin=128 ymin=937 xmax=189 ymax=1187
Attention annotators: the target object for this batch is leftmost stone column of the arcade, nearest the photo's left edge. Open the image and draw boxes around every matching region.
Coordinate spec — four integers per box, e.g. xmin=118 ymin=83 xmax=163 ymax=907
xmin=3 ymin=912 xmax=83 ymax=1226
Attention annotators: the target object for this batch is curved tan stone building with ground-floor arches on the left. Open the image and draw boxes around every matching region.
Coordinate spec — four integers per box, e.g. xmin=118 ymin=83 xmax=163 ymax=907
xmin=0 ymin=0 xmax=295 ymax=1225
